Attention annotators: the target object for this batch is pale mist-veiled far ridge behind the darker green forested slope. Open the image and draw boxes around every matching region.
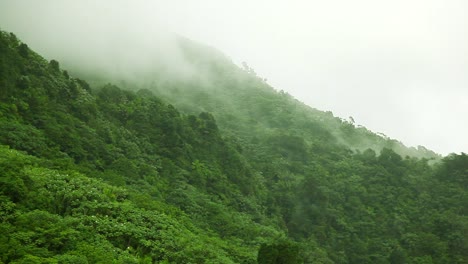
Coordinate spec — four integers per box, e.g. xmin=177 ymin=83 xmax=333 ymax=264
xmin=69 ymin=34 xmax=440 ymax=159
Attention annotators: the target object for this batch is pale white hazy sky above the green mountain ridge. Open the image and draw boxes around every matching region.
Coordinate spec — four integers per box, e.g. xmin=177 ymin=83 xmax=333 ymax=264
xmin=0 ymin=0 xmax=468 ymax=154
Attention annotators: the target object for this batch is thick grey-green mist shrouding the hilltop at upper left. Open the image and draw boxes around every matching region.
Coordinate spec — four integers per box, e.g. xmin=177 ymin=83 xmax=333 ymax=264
xmin=0 ymin=1 xmax=213 ymax=85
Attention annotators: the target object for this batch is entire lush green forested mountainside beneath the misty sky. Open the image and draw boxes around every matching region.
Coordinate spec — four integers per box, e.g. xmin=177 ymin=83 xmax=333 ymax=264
xmin=0 ymin=28 xmax=468 ymax=264
